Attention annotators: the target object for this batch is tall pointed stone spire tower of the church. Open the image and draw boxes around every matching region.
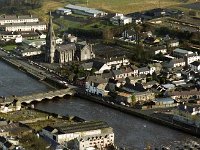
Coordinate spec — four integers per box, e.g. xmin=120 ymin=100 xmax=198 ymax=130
xmin=45 ymin=12 xmax=56 ymax=63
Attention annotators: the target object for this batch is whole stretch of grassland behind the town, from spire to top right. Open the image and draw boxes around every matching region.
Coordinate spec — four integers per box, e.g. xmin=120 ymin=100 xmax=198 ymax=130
xmin=31 ymin=0 xmax=196 ymax=21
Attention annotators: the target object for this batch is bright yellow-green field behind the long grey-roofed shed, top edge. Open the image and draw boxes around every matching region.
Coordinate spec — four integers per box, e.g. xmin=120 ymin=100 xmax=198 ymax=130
xmin=68 ymin=0 xmax=195 ymax=13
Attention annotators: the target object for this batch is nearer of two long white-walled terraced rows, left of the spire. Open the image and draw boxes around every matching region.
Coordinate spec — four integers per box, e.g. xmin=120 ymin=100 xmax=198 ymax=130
xmin=0 ymin=22 xmax=46 ymax=32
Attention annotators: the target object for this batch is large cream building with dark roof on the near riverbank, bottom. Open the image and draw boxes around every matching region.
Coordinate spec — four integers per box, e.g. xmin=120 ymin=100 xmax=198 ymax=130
xmin=41 ymin=121 xmax=114 ymax=150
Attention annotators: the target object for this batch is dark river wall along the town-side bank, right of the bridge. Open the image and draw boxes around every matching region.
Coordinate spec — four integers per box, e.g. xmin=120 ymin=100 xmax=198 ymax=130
xmin=75 ymin=93 xmax=200 ymax=137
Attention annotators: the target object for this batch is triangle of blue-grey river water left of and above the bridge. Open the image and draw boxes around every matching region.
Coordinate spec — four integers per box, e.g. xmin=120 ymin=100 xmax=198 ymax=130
xmin=0 ymin=61 xmax=50 ymax=96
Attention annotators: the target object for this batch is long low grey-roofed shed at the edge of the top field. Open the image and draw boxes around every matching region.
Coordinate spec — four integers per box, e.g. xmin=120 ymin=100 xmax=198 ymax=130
xmin=65 ymin=4 xmax=107 ymax=18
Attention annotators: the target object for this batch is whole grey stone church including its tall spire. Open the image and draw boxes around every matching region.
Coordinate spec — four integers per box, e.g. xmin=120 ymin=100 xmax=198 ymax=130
xmin=45 ymin=13 xmax=95 ymax=63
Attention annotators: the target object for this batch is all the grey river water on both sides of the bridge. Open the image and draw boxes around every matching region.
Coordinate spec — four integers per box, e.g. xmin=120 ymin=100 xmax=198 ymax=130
xmin=0 ymin=62 xmax=200 ymax=150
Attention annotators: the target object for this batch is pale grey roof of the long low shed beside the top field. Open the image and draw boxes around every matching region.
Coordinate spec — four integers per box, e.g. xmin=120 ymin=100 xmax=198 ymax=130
xmin=65 ymin=4 xmax=104 ymax=14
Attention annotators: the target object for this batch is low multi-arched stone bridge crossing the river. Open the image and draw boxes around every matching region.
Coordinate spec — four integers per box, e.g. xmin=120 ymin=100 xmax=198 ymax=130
xmin=0 ymin=88 xmax=76 ymax=104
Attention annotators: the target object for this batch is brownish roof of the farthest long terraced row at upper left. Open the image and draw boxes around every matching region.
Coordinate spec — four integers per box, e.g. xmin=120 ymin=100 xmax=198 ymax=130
xmin=0 ymin=15 xmax=38 ymax=20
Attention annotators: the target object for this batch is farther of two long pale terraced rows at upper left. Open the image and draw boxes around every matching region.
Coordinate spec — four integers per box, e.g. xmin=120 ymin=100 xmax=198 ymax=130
xmin=0 ymin=15 xmax=39 ymax=25
